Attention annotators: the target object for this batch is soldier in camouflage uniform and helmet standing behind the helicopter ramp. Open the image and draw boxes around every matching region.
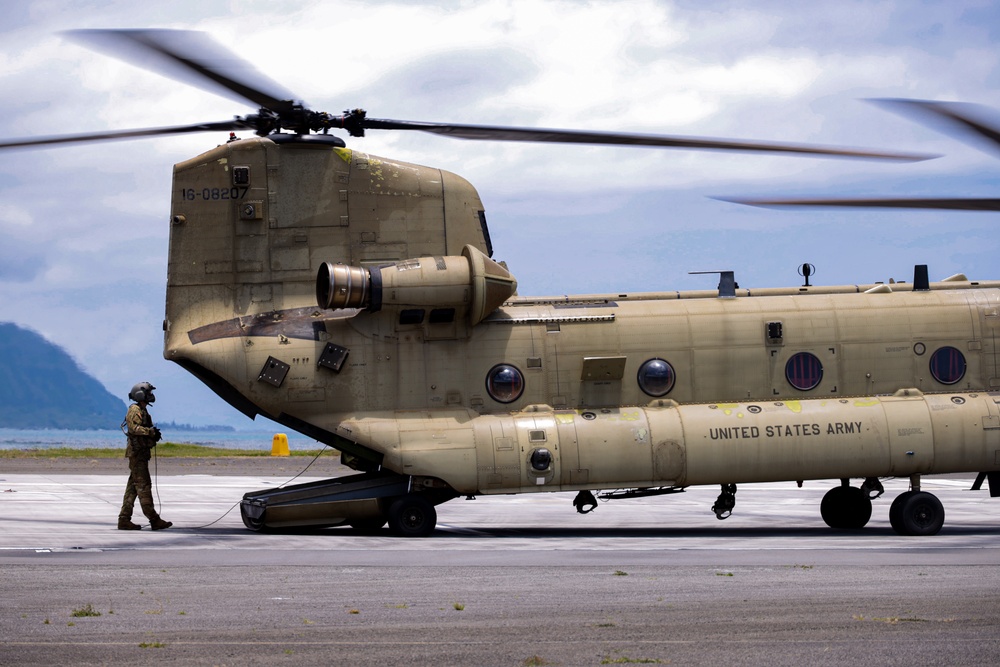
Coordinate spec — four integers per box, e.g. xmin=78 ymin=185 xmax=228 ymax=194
xmin=118 ymin=382 xmax=174 ymax=530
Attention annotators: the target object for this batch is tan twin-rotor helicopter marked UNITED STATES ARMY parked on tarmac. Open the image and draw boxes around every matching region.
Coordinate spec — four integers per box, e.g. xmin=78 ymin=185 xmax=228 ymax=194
xmin=7 ymin=31 xmax=1000 ymax=536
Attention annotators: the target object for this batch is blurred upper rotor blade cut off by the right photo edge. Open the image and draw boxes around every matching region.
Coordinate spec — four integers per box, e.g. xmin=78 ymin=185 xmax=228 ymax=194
xmin=869 ymin=98 xmax=1000 ymax=154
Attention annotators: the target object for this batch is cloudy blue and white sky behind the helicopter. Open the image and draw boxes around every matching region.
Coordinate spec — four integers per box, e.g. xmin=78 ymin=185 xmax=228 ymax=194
xmin=0 ymin=0 xmax=1000 ymax=429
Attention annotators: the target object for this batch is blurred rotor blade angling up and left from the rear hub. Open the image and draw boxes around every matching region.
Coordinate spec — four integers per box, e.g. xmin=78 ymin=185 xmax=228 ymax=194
xmin=66 ymin=30 xmax=294 ymax=112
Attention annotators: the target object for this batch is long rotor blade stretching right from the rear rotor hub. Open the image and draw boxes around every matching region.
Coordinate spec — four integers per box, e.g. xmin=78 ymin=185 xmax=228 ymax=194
xmin=361 ymin=118 xmax=938 ymax=162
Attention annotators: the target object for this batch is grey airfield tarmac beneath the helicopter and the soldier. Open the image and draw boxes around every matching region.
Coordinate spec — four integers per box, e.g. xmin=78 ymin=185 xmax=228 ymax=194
xmin=0 ymin=459 xmax=1000 ymax=666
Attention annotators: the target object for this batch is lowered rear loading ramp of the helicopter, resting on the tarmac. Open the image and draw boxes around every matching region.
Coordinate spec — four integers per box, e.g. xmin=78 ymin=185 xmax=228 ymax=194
xmin=240 ymin=473 xmax=410 ymax=531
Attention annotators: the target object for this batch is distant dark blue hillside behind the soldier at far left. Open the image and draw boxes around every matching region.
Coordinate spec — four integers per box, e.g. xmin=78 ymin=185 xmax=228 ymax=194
xmin=0 ymin=322 xmax=127 ymax=429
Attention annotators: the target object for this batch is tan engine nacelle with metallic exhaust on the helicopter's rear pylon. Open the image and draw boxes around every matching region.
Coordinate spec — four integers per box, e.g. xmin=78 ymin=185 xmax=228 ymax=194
xmin=316 ymin=245 xmax=517 ymax=326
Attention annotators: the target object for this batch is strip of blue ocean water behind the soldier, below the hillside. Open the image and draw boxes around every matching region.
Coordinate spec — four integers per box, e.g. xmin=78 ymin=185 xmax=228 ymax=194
xmin=0 ymin=428 xmax=323 ymax=452
